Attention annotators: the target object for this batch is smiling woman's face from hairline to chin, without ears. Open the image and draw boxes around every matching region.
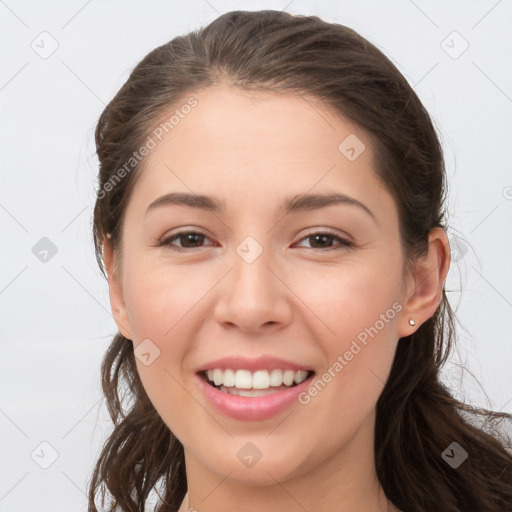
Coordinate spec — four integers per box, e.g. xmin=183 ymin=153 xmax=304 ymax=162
xmin=107 ymin=85 xmax=413 ymax=492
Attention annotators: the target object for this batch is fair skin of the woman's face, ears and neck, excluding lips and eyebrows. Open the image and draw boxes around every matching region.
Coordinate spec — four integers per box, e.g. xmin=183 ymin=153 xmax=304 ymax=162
xmin=104 ymin=84 xmax=450 ymax=512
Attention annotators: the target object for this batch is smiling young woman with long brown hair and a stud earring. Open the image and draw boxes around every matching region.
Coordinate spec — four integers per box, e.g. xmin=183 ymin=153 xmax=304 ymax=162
xmin=89 ymin=11 xmax=512 ymax=512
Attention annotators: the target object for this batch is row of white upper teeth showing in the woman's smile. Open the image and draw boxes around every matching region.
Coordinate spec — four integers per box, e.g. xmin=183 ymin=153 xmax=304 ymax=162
xmin=206 ymin=368 xmax=309 ymax=390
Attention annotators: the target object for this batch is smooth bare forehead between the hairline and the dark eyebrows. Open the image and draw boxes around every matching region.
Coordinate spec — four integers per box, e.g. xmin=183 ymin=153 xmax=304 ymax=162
xmin=126 ymin=85 xmax=389 ymax=218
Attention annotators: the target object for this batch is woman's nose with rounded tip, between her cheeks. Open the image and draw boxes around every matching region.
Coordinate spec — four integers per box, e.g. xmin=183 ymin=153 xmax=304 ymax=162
xmin=215 ymin=247 xmax=292 ymax=334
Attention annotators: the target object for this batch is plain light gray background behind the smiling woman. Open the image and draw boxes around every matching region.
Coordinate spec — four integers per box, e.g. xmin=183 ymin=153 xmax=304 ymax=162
xmin=0 ymin=0 xmax=512 ymax=512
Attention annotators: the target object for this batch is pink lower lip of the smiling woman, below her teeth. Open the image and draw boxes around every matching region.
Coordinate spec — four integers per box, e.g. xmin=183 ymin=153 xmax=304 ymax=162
xmin=196 ymin=374 xmax=315 ymax=421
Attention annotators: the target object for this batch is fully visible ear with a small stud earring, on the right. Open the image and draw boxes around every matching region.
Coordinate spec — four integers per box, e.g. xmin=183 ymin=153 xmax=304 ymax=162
xmin=398 ymin=228 xmax=451 ymax=337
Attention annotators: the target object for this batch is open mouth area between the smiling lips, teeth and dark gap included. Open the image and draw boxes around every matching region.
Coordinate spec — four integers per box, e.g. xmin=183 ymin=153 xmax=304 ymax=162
xmin=198 ymin=369 xmax=315 ymax=397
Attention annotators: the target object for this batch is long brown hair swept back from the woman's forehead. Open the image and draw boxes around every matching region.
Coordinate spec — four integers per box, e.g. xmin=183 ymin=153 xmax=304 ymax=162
xmin=89 ymin=11 xmax=512 ymax=512
